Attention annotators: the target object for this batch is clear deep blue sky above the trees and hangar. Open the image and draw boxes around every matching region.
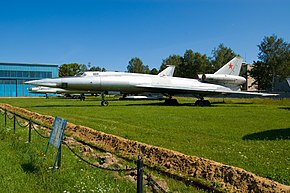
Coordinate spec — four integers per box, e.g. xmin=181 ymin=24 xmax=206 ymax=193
xmin=0 ymin=0 xmax=290 ymax=71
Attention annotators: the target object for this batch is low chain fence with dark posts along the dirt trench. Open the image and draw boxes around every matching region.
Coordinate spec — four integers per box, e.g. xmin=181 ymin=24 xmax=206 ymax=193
xmin=0 ymin=107 xmax=167 ymax=193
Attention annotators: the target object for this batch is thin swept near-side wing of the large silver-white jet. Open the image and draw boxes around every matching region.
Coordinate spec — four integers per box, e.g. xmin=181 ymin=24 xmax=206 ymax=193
xmin=137 ymin=85 xmax=278 ymax=97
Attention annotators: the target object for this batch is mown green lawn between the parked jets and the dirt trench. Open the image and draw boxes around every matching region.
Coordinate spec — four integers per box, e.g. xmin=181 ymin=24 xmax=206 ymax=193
xmin=0 ymin=98 xmax=290 ymax=185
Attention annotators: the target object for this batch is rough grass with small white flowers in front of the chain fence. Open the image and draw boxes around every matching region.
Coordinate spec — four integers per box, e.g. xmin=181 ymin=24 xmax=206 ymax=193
xmin=0 ymin=116 xmax=136 ymax=193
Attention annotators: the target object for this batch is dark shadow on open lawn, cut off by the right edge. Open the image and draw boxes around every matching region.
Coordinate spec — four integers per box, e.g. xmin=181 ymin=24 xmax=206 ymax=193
xmin=243 ymin=128 xmax=290 ymax=141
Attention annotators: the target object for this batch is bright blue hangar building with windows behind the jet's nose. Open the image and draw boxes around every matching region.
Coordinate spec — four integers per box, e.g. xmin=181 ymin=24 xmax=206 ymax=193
xmin=0 ymin=63 xmax=58 ymax=97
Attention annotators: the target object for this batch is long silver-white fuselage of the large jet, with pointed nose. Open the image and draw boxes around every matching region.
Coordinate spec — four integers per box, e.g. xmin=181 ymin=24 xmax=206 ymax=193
xmin=28 ymin=72 xmax=230 ymax=94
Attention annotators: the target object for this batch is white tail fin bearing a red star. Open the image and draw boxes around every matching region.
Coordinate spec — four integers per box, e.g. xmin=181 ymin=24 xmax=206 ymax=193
xmin=214 ymin=56 xmax=243 ymax=76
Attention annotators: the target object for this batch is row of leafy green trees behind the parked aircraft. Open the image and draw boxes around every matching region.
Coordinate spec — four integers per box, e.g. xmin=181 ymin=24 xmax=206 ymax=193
xmin=59 ymin=34 xmax=290 ymax=90
